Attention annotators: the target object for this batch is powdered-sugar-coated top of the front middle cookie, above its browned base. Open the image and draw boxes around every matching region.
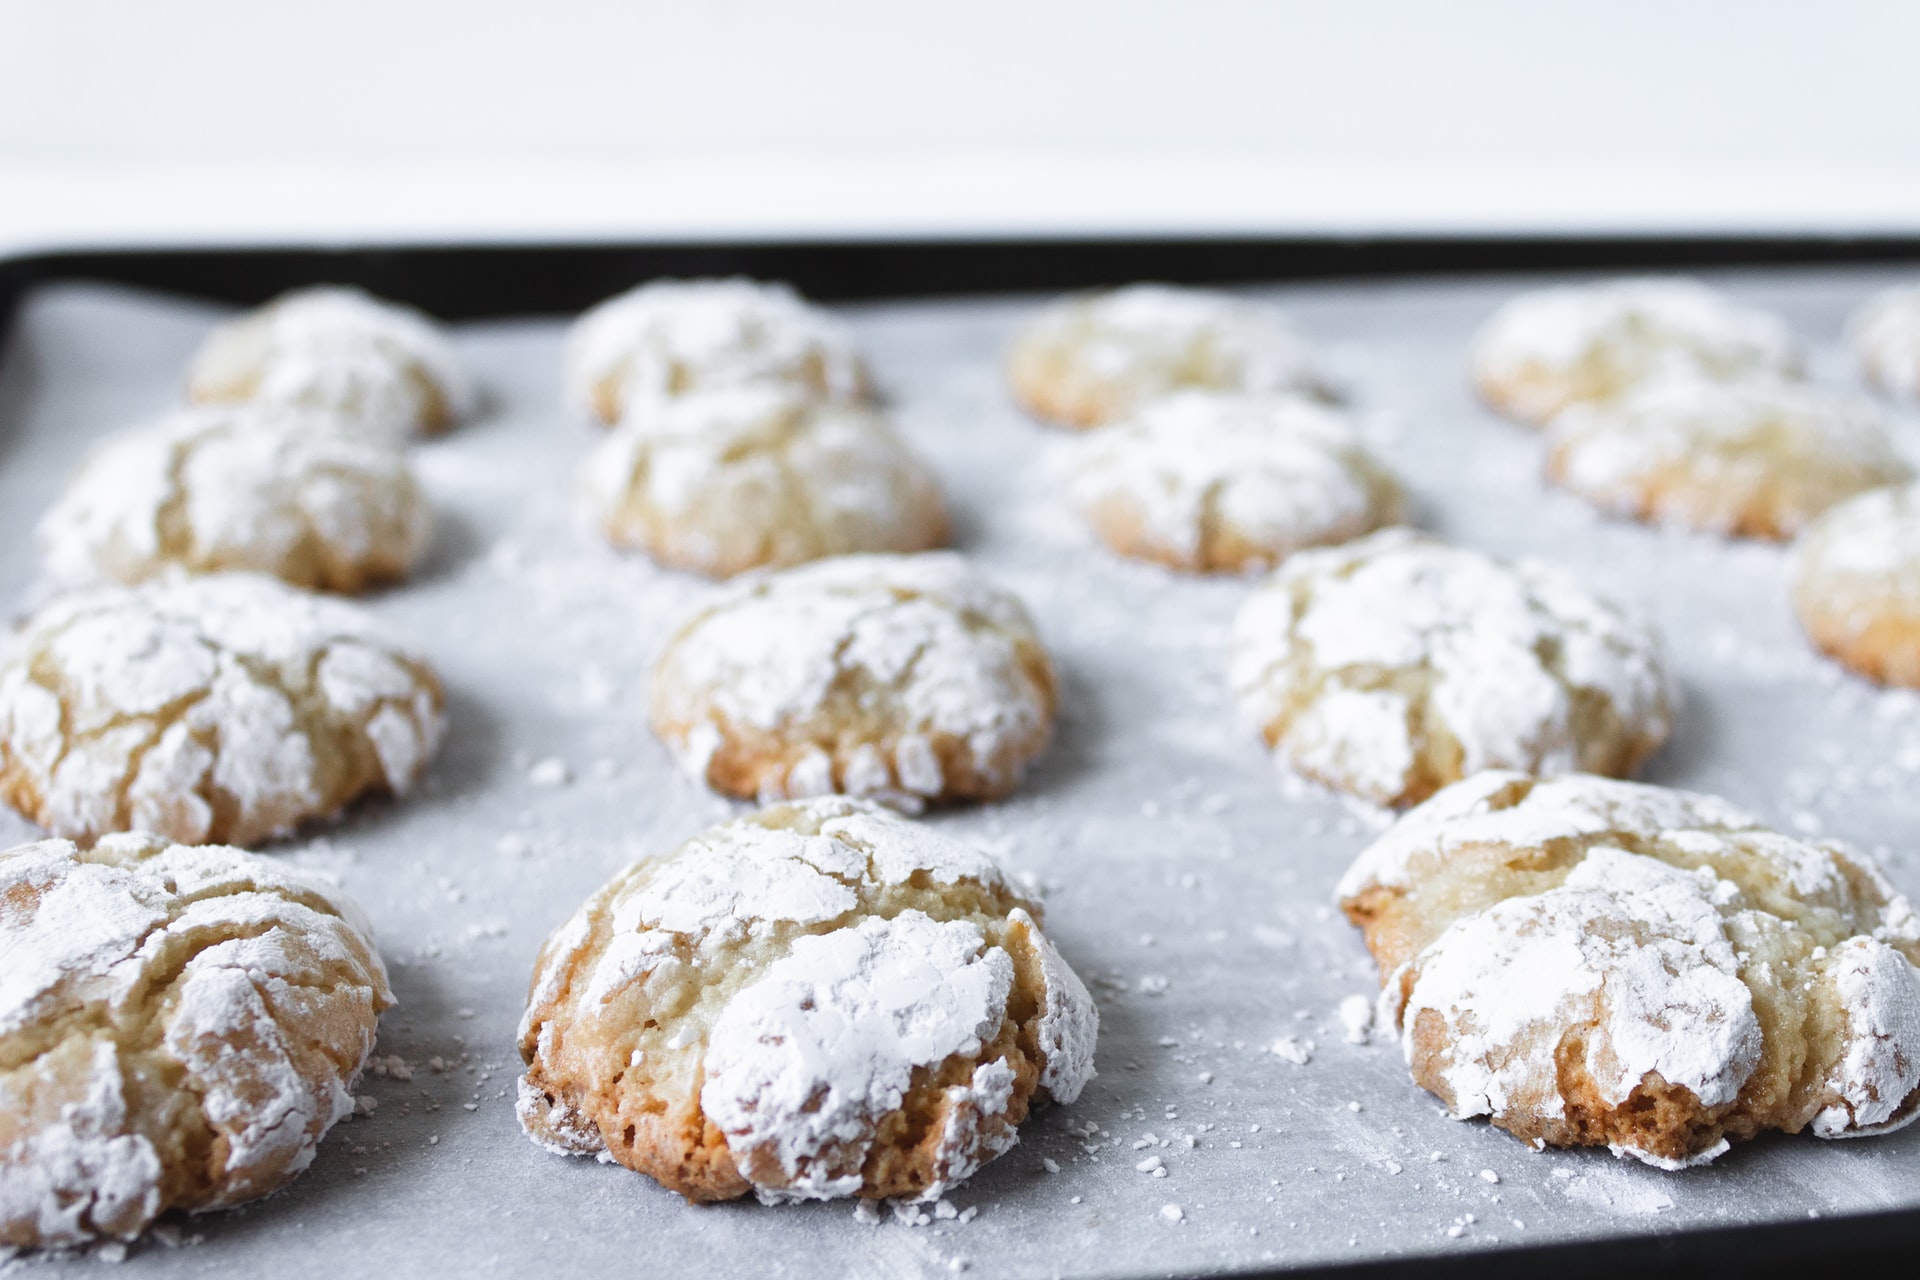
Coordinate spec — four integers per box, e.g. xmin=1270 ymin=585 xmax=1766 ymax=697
xmin=520 ymin=796 xmax=1098 ymax=1199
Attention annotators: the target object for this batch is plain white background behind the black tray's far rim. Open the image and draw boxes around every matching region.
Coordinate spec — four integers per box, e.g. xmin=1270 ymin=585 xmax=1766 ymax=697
xmin=0 ymin=0 xmax=1920 ymax=251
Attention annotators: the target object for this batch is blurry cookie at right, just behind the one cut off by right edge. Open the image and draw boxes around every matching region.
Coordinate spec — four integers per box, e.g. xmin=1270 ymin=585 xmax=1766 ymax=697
xmin=1548 ymin=378 xmax=1912 ymax=539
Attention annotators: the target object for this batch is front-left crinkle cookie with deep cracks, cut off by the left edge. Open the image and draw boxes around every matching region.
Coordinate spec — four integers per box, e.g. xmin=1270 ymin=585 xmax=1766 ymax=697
xmin=0 ymin=835 xmax=394 ymax=1247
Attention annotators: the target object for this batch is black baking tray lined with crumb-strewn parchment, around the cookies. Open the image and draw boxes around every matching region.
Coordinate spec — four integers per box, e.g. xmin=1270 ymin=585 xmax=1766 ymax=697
xmin=0 ymin=242 xmax=1920 ymax=1276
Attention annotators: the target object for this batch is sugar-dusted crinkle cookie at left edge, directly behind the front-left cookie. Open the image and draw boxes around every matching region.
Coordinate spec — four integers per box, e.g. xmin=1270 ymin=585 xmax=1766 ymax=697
xmin=0 ymin=574 xmax=442 ymax=844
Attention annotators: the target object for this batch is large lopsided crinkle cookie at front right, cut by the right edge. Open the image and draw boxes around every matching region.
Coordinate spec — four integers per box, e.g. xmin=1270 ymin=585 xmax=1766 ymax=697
xmin=1340 ymin=773 xmax=1920 ymax=1169
